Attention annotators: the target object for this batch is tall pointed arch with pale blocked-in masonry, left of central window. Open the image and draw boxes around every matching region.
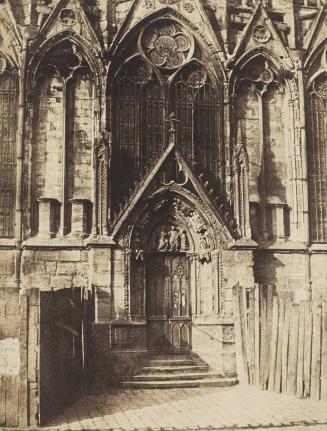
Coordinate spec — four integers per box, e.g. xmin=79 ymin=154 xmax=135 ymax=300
xmin=28 ymin=31 xmax=101 ymax=235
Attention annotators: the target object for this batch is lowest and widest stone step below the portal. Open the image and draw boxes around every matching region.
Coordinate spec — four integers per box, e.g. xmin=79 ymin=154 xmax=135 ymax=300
xmin=121 ymin=378 xmax=238 ymax=389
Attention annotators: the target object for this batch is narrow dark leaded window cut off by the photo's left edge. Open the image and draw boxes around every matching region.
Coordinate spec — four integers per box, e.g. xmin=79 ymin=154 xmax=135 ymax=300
xmin=0 ymin=53 xmax=17 ymax=237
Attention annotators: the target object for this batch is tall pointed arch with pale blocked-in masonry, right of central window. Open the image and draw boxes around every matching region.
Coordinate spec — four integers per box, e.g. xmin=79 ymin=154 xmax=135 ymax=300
xmin=231 ymin=48 xmax=296 ymax=241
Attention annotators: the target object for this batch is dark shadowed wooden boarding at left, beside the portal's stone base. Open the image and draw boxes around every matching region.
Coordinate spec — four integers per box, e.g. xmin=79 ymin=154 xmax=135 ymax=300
xmin=39 ymin=288 xmax=93 ymax=425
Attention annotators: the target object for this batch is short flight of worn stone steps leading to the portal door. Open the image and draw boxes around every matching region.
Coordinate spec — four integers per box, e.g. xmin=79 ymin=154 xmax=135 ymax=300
xmin=121 ymin=355 xmax=238 ymax=389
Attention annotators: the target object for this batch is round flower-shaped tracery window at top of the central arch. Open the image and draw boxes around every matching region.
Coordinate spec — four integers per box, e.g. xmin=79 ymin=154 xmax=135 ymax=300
xmin=142 ymin=22 xmax=193 ymax=69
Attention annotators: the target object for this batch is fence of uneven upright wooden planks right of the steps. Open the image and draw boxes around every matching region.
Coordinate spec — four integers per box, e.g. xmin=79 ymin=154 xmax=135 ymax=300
xmin=233 ymin=285 xmax=327 ymax=401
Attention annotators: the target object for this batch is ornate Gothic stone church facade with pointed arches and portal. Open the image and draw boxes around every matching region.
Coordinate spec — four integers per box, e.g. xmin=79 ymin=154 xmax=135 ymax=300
xmin=0 ymin=0 xmax=327 ymax=426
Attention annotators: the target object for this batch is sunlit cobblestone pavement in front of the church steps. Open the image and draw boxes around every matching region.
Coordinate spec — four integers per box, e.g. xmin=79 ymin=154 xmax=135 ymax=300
xmin=42 ymin=385 xmax=327 ymax=431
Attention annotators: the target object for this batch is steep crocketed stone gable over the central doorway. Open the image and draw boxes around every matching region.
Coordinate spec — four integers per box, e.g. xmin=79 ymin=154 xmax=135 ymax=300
xmin=111 ymin=143 xmax=237 ymax=248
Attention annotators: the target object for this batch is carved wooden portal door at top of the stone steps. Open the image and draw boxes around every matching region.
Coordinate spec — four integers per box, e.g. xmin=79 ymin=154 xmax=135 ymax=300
xmin=146 ymin=253 xmax=191 ymax=353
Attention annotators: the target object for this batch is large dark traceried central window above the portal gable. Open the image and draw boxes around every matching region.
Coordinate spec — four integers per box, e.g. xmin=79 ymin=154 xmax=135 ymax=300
xmin=112 ymin=19 xmax=223 ymax=211
